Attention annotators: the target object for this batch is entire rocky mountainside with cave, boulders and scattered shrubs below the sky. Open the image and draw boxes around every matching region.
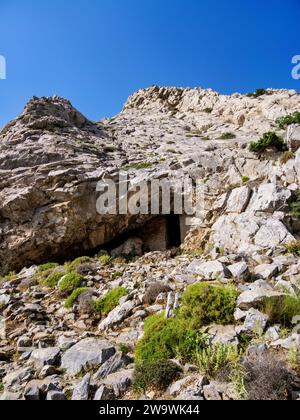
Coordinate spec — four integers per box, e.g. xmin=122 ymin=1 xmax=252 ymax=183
xmin=0 ymin=87 xmax=300 ymax=400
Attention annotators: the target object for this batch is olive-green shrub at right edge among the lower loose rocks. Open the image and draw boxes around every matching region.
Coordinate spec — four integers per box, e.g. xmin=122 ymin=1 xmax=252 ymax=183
xmin=260 ymin=295 xmax=300 ymax=327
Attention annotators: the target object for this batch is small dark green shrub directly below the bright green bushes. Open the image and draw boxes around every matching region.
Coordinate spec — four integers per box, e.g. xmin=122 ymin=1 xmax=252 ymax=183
xmin=133 ymin=360 xmax=181 ymax=392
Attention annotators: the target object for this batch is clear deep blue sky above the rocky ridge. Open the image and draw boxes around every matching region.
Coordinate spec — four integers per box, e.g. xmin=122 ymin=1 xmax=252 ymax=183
xmin=0 ymin=0 xmax=300 ymax=126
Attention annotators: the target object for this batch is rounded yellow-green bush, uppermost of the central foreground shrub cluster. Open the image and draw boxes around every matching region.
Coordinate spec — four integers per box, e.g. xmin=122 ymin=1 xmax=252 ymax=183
xmin=180 ymin=283 xmax=238 ymax=328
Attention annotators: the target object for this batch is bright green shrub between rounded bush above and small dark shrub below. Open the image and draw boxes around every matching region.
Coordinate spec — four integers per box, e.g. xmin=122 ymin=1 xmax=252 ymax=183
xmin=135 ymin=313 xmax=206 ymax=363
